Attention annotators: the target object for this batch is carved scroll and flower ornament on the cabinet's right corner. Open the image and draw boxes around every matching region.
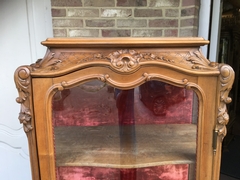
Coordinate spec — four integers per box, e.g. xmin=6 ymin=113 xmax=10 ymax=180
xmin=215 ymin=64 xmax=234 ymax=140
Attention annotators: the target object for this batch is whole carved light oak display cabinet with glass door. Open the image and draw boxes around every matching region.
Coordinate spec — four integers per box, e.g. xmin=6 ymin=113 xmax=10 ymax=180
xmin=15 ymin=38 xmax=234 ymax=180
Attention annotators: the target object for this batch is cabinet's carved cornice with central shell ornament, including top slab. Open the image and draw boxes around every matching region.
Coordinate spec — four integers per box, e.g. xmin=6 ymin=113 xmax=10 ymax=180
xmin=28 ymin=37 xmax=219 ymax=77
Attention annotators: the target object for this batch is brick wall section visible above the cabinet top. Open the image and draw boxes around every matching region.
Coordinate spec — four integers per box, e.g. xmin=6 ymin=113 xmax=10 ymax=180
xmin=51 ymin=0 xmax=199 ymax=37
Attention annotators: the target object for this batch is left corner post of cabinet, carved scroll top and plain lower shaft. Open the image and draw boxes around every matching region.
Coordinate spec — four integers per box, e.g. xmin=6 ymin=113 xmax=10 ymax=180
xmin=14 ymin=66 xmax=40 ymax=180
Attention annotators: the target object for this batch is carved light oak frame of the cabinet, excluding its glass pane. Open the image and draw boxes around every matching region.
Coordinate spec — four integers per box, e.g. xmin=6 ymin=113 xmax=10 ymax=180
xmin=15 ymin=38 xmax=234 ymax=180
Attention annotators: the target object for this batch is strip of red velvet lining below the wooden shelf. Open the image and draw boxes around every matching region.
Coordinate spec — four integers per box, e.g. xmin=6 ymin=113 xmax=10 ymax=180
xmin=57 ymin=164 xmax=188 ymax=180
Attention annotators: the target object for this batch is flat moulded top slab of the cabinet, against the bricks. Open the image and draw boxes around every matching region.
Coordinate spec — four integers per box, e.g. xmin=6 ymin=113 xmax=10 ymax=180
xmin=42 ymin=37 xmax=209 ymax=48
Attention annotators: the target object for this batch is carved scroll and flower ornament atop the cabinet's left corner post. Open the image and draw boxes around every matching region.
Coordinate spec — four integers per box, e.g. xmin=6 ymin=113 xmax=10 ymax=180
xmin=14 ymin=66 xmax=33 ymax=133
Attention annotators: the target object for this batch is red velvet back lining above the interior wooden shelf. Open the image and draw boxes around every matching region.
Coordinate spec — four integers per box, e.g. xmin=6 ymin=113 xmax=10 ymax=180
xmin=53 ymin=88 xmax=193 ymax=126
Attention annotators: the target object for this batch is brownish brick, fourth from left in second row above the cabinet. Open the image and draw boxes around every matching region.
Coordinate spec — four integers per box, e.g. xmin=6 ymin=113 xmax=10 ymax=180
xmin=149 ymin=19 xmax=178 ymax=27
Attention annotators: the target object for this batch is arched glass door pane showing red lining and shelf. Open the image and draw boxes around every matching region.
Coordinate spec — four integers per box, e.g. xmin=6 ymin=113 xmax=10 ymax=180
xmin=52 ymin=81 xmax=198 ymax=180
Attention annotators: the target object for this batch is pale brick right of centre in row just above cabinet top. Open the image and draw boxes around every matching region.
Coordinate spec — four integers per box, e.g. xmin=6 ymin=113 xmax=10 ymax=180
xmin=132 ymin=29 xmax=162 ymax=37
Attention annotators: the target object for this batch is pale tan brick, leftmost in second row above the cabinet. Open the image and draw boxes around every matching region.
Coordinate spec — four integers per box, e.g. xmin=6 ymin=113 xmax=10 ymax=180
xmin=53 ymin=19 xmax=83 ymax=27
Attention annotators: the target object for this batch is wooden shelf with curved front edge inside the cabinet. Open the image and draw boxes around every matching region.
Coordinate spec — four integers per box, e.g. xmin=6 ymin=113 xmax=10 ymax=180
xmin=54 ymin=124 xmax=197 ymax=168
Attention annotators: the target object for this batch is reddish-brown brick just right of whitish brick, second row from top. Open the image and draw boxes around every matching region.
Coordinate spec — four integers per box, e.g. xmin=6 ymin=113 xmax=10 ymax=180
xmin=134 ymin=9 xmax=162 ymax=17
